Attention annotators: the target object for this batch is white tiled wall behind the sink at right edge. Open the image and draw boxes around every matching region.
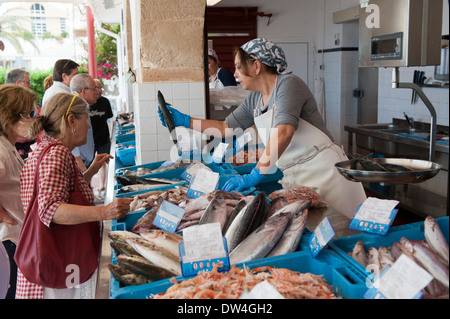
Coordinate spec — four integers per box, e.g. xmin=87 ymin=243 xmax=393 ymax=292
xmin=378 ymin=66 xmax=449 ymax=126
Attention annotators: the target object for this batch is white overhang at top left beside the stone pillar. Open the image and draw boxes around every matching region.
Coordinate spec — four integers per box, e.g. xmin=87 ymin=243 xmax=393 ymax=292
xmin=0 ymin=0 xmax=122 ymax=23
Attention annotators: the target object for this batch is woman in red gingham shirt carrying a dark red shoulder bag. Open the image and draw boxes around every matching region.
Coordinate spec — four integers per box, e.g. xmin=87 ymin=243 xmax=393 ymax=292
xmin=16 ymin=93 xmax=132 ymax=299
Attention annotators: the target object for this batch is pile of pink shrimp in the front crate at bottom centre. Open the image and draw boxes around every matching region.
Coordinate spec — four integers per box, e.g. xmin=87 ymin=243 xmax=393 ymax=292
xmin=153 ymin=266 xmax=338 ymax=299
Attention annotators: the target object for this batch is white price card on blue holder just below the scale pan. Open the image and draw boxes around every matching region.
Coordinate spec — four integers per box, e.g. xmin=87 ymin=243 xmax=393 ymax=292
xmin=354 ymin=197 xmax=399 ymax=225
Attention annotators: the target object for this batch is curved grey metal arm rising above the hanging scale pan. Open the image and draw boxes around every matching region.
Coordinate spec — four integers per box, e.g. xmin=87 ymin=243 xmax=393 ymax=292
xmin=392 ymin=67 xmax=437 ymax=162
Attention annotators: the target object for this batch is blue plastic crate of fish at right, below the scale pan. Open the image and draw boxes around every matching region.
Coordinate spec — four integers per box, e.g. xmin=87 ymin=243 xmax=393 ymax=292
xmin=329 ymin=217 xmax=449 ymax=277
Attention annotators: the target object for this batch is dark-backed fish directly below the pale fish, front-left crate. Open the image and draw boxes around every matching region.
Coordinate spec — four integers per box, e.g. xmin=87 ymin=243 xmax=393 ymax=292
xmin=117 ymin=255 xmax=176 ymax=281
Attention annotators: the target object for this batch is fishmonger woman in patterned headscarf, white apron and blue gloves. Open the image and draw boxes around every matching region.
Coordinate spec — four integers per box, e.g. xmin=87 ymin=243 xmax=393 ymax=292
xmin=163 ymin=38 xmax=367 ymax=217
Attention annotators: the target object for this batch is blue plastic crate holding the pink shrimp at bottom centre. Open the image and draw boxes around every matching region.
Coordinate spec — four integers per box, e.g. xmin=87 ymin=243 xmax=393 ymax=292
xmin=111 ymin=252 xmax=367 ymax=299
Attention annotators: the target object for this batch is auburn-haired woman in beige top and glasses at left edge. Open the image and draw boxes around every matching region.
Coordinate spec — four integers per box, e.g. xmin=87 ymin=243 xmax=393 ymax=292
xmin=0 ymin=84 xmax=37 ymax=299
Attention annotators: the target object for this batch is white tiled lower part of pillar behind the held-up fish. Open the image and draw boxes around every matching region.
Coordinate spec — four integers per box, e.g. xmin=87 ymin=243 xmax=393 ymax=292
xmin=133 ymin=82 xmax=206 ymax=165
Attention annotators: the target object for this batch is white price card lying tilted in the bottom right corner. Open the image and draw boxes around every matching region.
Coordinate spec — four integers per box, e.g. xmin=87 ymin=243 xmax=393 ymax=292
xmin=375 ymin=254 xmax=433 ymax=299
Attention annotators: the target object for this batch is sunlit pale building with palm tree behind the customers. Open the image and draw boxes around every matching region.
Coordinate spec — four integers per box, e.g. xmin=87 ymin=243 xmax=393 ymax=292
xmin=0 ymin=2 xmax=87 ymax=69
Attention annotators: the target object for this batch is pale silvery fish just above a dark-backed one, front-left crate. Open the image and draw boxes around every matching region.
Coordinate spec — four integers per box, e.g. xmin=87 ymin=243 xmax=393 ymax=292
xmin=127 ymin=238 xmax=181 ymax=276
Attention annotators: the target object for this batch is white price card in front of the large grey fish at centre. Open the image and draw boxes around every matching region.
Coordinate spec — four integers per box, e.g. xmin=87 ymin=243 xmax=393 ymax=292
xmin=183 ymin=223 xmax=227 ymax=263
